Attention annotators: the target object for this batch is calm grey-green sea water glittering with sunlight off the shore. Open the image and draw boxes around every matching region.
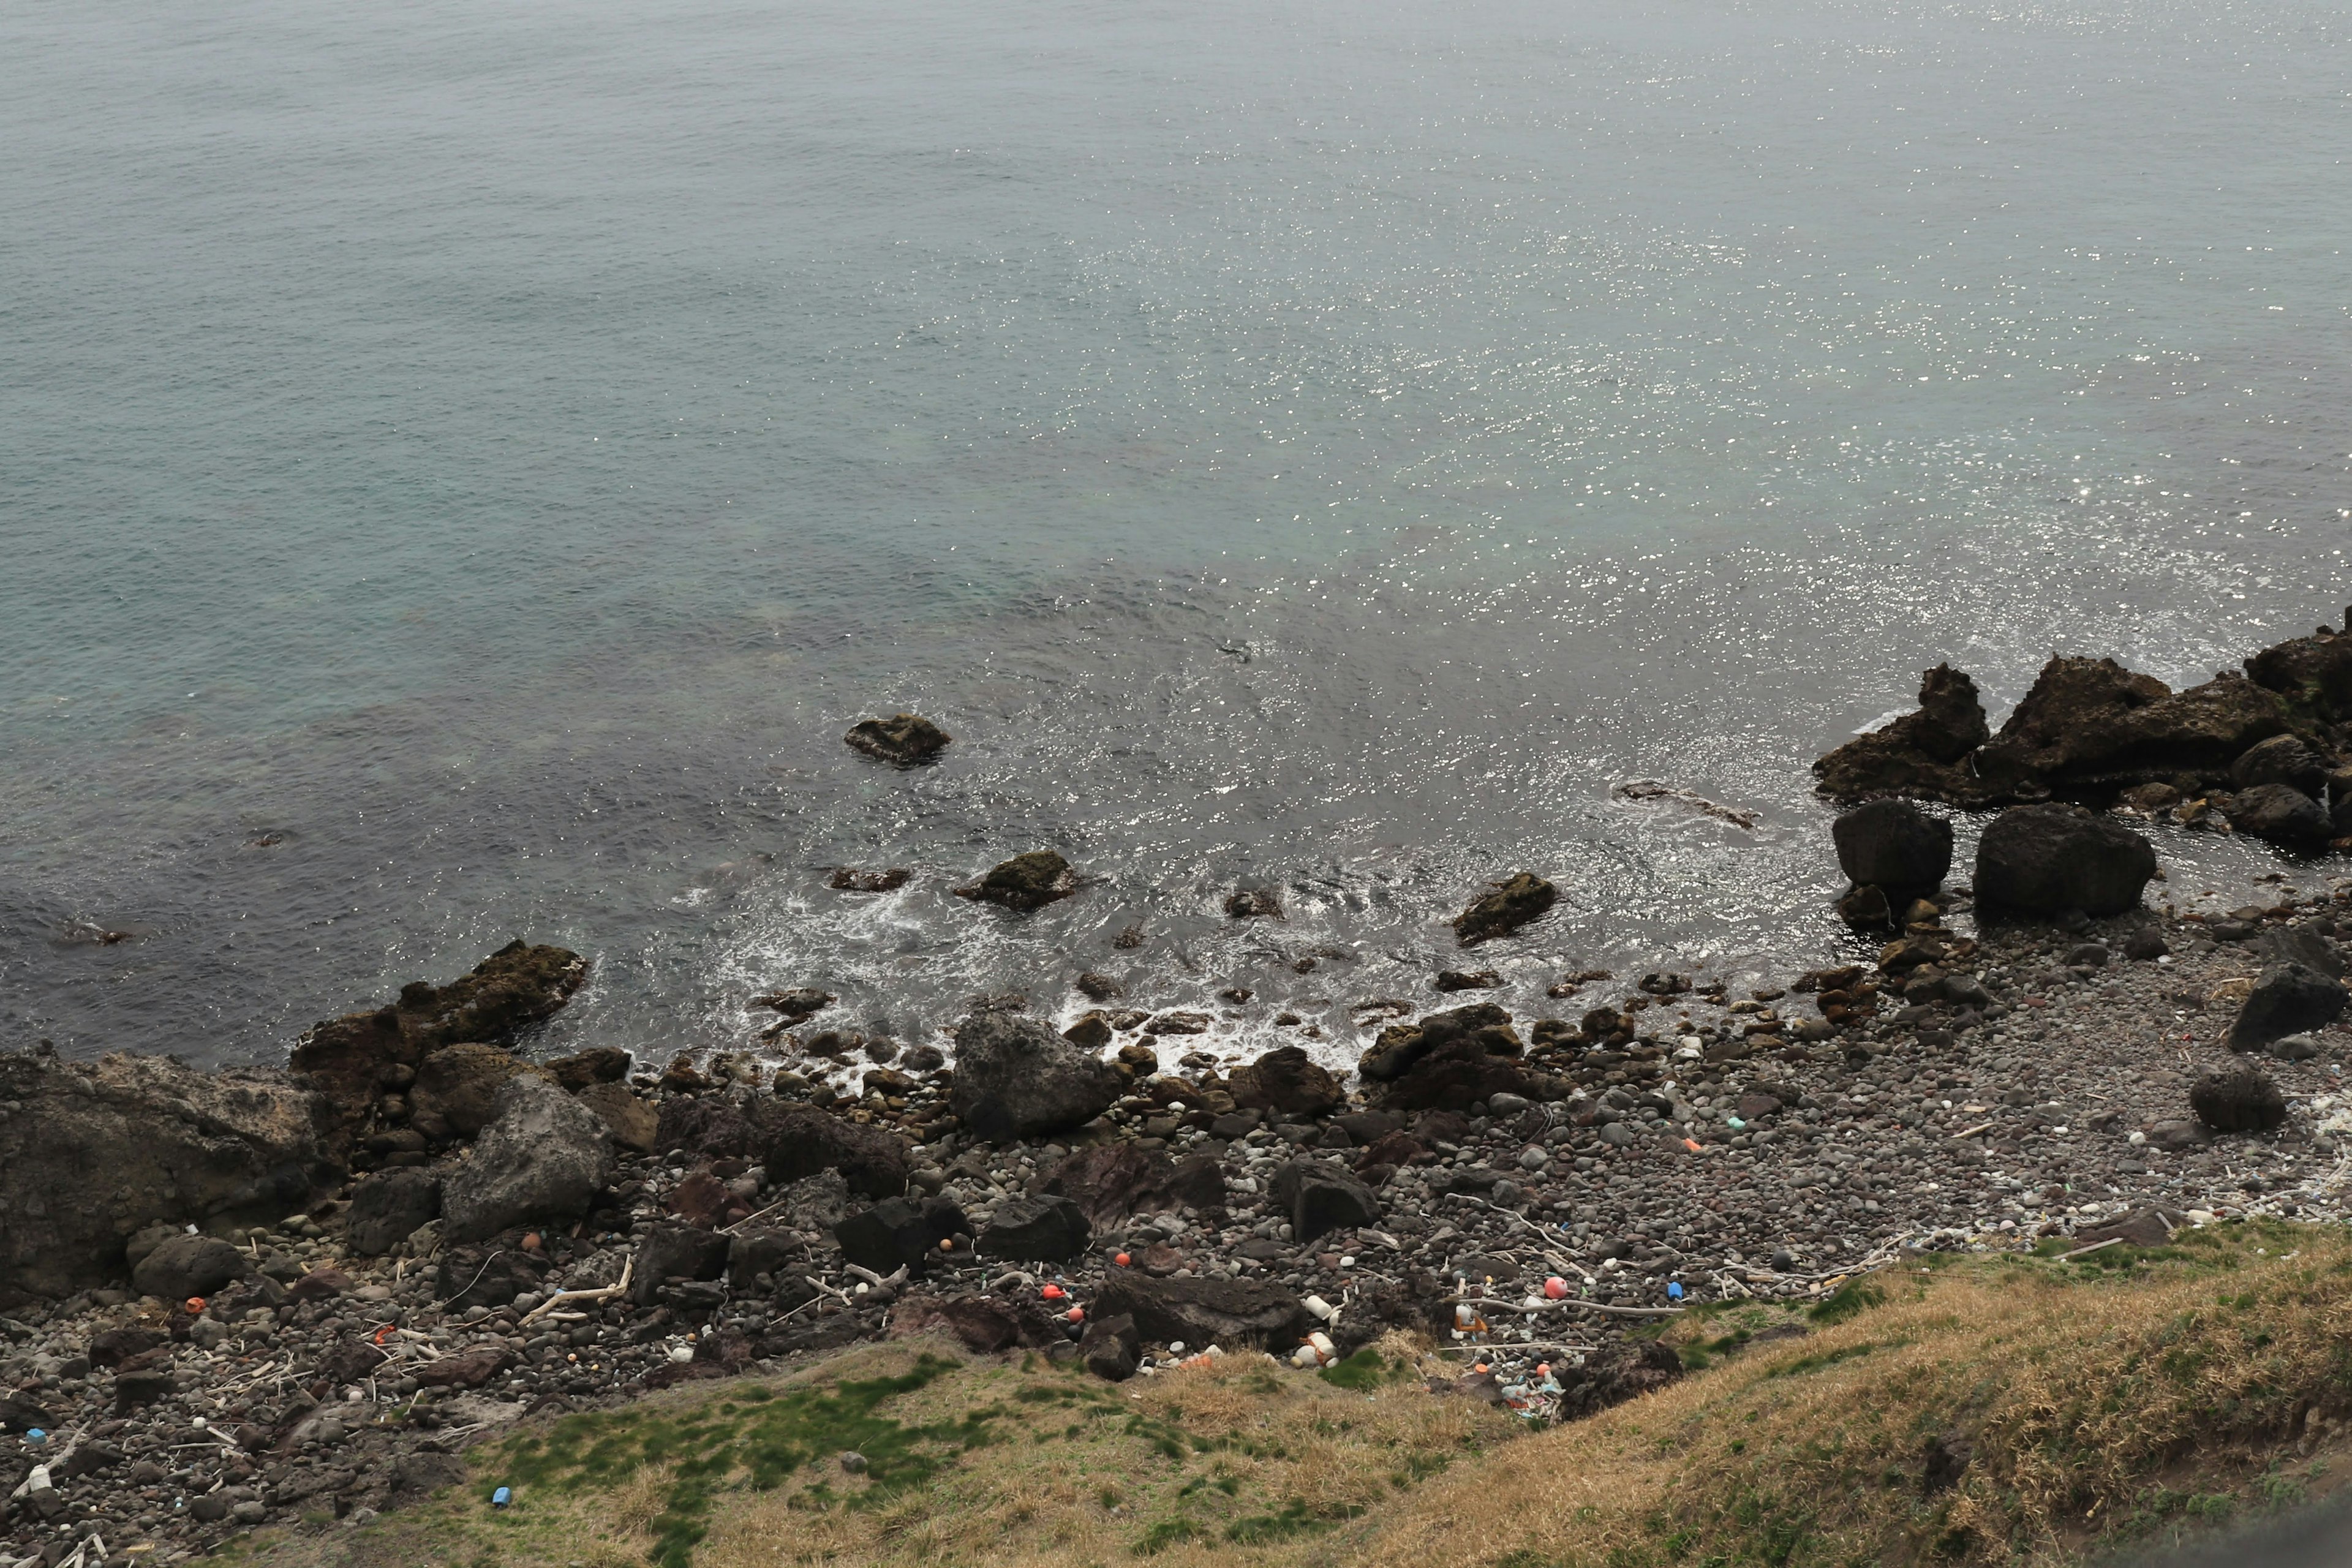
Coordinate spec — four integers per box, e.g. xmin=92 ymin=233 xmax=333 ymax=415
xmin=0 ymin=0 xmax=2352 ymax=1063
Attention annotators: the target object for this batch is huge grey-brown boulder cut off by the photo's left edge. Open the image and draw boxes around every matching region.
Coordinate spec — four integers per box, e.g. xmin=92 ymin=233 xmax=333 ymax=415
xmin=0 ymin=1051 xmax=341 ymax=1312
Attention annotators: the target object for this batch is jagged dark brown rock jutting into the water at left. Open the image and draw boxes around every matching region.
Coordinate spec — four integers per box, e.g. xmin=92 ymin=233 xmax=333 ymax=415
xmin=289 ymin=940 xmax=588 ymax=1138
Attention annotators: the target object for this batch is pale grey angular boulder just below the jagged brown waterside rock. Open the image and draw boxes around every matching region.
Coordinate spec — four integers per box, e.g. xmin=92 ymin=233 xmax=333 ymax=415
xmin=442 ymin=1077 xmax=611 ymax=1242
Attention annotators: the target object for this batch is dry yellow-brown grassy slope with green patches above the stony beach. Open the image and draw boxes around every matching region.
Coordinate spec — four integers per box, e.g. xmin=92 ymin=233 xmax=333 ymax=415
xmin=229 ymin=1225 xmax=2352 ymax=1568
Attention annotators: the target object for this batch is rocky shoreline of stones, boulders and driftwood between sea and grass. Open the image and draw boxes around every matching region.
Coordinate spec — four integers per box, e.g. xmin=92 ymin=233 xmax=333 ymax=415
xmin=0 ymin=635 xmax=2352 ymax=1568
